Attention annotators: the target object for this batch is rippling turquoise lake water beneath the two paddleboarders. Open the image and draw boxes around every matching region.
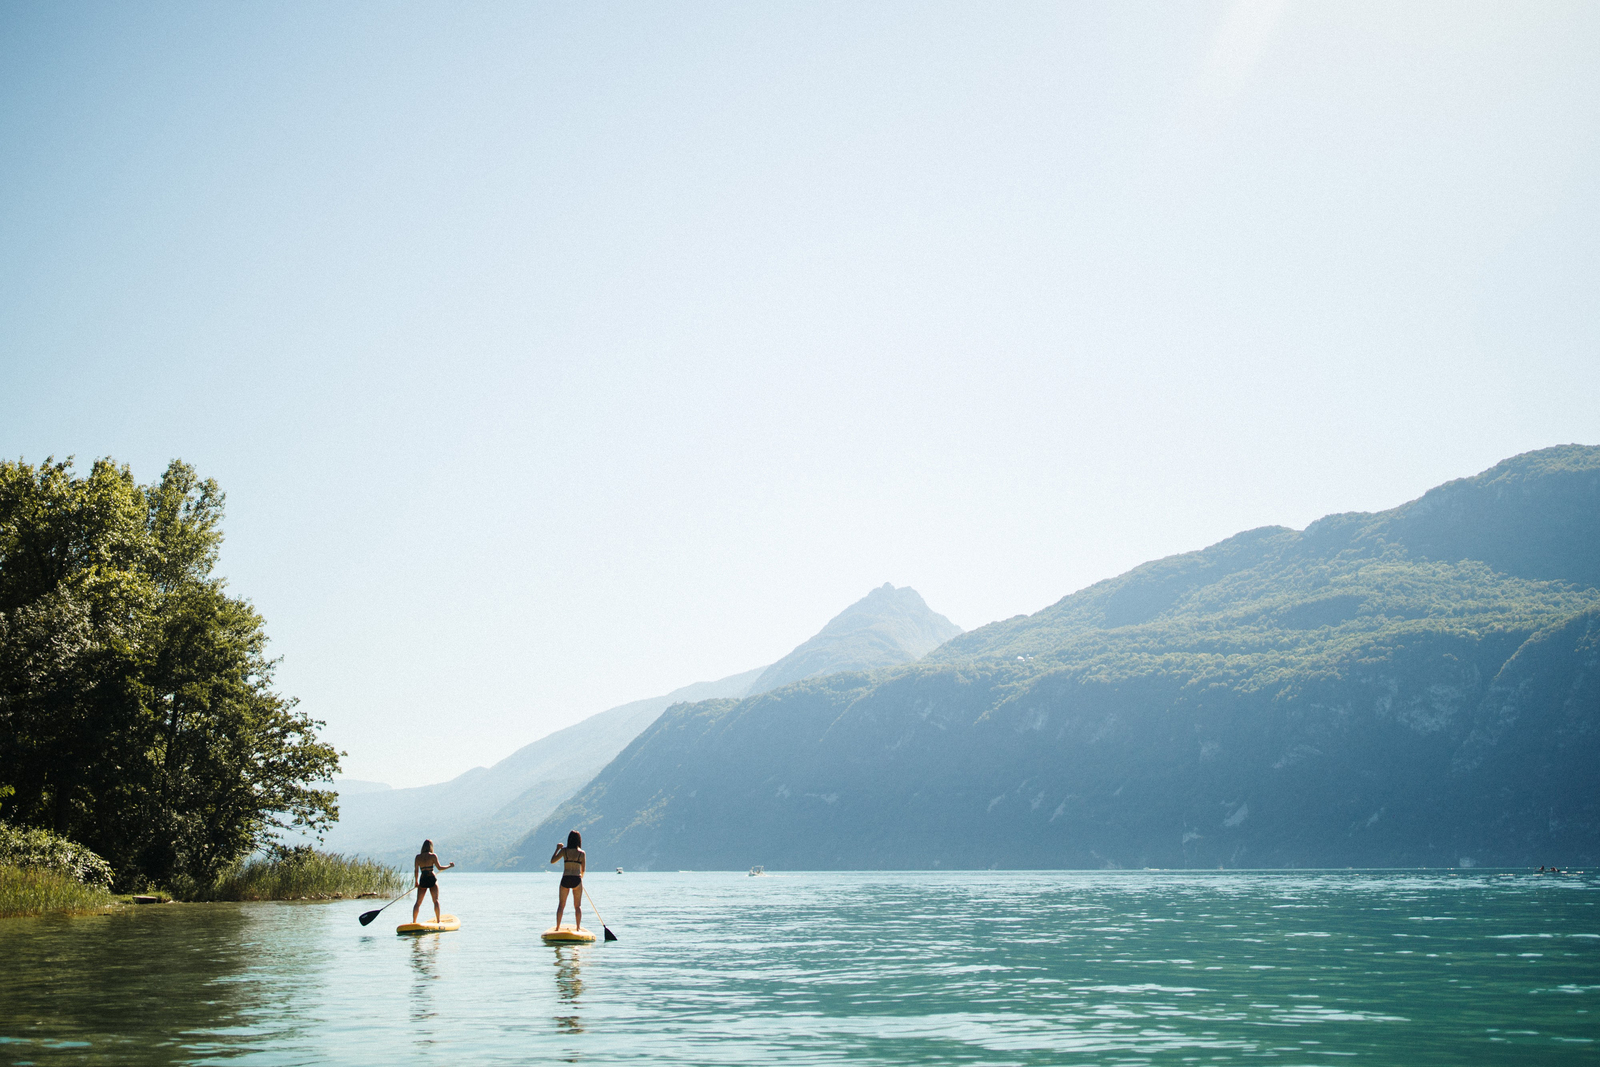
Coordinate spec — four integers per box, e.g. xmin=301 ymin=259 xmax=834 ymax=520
xmin=0 ymin=872 xmax=1600 ymax=1065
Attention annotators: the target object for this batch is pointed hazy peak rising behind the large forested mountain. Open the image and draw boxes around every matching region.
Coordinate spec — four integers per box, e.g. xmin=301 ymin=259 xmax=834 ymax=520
xmin=750 ymin=582 xmax=962 ymax=694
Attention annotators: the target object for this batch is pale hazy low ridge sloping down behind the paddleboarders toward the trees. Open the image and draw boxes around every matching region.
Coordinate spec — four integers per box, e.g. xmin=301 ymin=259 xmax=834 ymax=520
xmin=323 ymin=667 xmax=762 ymax=870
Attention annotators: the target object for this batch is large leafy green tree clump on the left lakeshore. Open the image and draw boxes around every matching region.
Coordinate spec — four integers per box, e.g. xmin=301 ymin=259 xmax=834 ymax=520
xmin=0 ymin=459 xmax=341 ymax=885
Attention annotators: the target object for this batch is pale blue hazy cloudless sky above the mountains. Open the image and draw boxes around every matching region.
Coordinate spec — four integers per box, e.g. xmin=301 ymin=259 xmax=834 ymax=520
xmin=9 ymin=0 xmax=1600 ymax=785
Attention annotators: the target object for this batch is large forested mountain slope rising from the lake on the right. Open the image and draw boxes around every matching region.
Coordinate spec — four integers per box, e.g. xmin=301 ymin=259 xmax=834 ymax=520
xmin=530 ymin=445 xmax=1600 ymax=869
